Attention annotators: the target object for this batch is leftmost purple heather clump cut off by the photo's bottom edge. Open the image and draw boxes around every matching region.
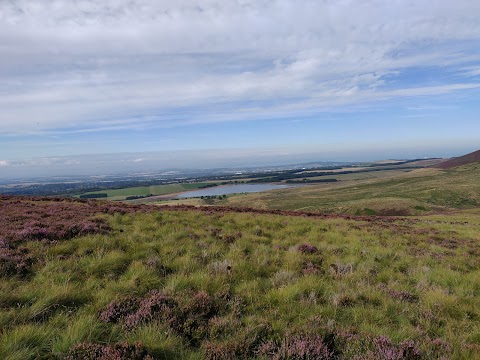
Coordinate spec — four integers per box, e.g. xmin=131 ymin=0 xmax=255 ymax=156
xmin=65 ymin=342 xmax=154 ymax=360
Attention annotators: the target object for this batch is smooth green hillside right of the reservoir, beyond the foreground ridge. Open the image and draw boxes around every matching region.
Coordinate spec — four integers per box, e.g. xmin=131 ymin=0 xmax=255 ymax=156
xmin=228 ymin=163 xmax=480 ymax=214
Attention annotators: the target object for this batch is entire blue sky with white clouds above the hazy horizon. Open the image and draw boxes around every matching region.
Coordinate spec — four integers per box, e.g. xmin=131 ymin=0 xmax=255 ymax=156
xmin=0 ymin=0 xmax=480 ymax=177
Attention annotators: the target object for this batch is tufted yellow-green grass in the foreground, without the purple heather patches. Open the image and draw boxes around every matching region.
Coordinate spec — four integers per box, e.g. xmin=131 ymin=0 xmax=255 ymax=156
xmin=0 ymin=204 xmax=480 ymax=359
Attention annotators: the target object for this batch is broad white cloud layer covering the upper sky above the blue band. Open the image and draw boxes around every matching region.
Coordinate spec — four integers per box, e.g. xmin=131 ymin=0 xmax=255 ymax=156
xmin=0 ymin=0 xmax=480 ymax=134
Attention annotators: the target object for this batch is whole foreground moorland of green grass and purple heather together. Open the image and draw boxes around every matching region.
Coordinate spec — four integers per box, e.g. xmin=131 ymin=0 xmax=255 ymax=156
xmin=0 ymin=197 xmax=480 ymax=360
